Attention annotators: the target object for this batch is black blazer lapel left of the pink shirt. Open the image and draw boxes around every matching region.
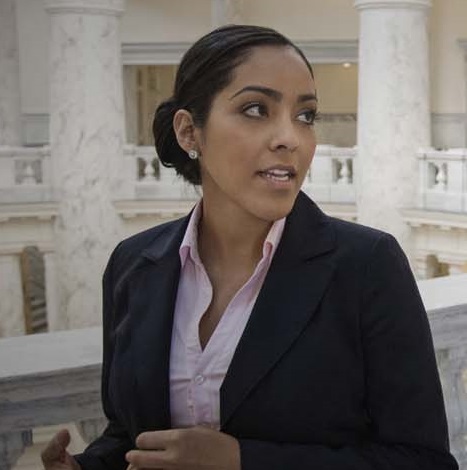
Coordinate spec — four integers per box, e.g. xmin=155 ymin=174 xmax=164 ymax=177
xmin=128 ymin=217 xmax=188 ymax=432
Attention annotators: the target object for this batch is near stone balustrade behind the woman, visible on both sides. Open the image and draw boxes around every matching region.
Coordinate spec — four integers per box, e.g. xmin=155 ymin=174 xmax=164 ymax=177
xmin=0 ymin=275 xmax=467 ymax=470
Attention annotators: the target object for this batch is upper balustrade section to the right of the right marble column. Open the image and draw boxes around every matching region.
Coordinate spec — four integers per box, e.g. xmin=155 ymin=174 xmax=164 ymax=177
xmin=417 ymin=149 xmax=467 ymax=212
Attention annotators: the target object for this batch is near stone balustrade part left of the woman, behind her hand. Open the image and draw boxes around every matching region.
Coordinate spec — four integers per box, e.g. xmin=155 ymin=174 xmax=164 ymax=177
xmin=0 ymin=327 xmax=105 ymax=470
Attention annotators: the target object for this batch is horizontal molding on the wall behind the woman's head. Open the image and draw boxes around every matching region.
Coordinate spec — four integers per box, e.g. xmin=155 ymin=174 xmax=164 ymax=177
xmin=122 ymin=39 xmax=358 ymax=65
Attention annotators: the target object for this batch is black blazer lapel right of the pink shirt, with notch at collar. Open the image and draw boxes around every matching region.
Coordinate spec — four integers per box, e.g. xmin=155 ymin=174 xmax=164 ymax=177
xmin=221 ymin=193 xmax=335 ymax=427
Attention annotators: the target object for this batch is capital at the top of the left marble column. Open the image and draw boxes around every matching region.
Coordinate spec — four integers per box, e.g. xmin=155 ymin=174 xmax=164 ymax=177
xmin=45 ymin=0 xmax=125 ymax=16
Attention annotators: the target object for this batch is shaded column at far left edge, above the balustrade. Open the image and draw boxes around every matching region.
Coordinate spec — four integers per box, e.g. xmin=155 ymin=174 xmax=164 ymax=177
xmin=0 ymin=0 xmax=21 ymax=146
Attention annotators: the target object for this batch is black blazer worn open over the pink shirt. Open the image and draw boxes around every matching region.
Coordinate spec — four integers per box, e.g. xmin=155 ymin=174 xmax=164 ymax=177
xmin=77 ymin=193 xmax=457 ymax=470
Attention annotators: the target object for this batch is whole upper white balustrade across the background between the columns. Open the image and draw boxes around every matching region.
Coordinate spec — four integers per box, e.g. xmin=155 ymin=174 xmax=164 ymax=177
xmin=0 ymin=145 xmax=467 ymax=213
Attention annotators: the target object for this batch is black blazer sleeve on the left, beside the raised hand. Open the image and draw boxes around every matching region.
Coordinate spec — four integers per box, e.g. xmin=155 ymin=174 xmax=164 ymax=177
xmin=74 ymin=245 xmax=134 ymax=470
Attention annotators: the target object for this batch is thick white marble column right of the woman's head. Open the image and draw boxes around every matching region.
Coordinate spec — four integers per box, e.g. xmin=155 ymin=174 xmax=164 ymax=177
xmin=354 ymin=0 xmax=431 ymax=256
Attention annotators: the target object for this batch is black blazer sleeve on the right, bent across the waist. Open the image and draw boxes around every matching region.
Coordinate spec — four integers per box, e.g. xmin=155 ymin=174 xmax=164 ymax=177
xmin=239 ymin=234 xmax=458 ymax=470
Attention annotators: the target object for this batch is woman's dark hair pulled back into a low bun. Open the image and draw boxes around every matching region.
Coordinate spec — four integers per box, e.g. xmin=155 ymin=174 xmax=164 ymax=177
xmin=152 ymin=25 xmax=313 ymax=185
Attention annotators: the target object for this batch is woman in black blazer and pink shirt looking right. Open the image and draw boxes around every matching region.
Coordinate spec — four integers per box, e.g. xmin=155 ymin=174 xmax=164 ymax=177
xmin=43 ymin=26 xmax=457 ymax=470
